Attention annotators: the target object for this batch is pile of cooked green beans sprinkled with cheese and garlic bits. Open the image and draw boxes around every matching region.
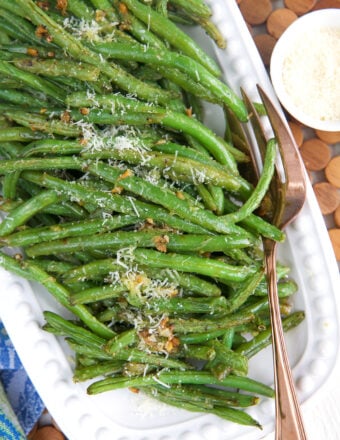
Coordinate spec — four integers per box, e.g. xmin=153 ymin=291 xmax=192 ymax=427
xmin=0 ymin=0 xmax=304 ymax=427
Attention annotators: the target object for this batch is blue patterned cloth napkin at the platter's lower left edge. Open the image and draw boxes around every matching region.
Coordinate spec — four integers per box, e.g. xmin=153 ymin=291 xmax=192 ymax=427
xmin=0 ymin=321 xmax=45 ymax=440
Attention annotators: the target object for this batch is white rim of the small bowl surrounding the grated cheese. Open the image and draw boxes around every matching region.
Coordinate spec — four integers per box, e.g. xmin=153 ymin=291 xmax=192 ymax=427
xmin=269 ymin=8 xmax=340 ymax=131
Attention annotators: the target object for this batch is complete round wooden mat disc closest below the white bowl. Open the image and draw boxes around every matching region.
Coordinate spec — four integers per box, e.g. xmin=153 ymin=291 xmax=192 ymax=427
xmin=300 ymin=138 xmax=331 ymax=171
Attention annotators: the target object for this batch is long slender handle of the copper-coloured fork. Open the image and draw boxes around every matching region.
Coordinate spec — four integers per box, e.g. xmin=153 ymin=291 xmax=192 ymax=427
xmin=264 ymin=239 xmax=307 ymax=440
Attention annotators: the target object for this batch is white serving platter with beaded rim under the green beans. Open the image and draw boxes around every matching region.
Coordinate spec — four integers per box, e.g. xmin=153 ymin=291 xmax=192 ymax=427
xmin=0 ymin=0 xmax=340 ymax=440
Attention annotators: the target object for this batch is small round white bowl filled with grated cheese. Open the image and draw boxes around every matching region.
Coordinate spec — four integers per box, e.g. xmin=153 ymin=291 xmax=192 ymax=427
xmin=270 ymin=9 xmax=340 ymax=131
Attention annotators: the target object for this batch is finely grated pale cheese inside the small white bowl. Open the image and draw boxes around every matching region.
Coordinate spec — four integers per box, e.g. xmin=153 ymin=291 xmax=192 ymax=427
xmin=282 ymin=27 xmax=340 ymax=121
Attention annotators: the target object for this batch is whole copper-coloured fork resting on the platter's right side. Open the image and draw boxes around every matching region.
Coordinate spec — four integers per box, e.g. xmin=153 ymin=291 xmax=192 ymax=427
xmin=243 ymin=87 xmax=307 ymax=440
